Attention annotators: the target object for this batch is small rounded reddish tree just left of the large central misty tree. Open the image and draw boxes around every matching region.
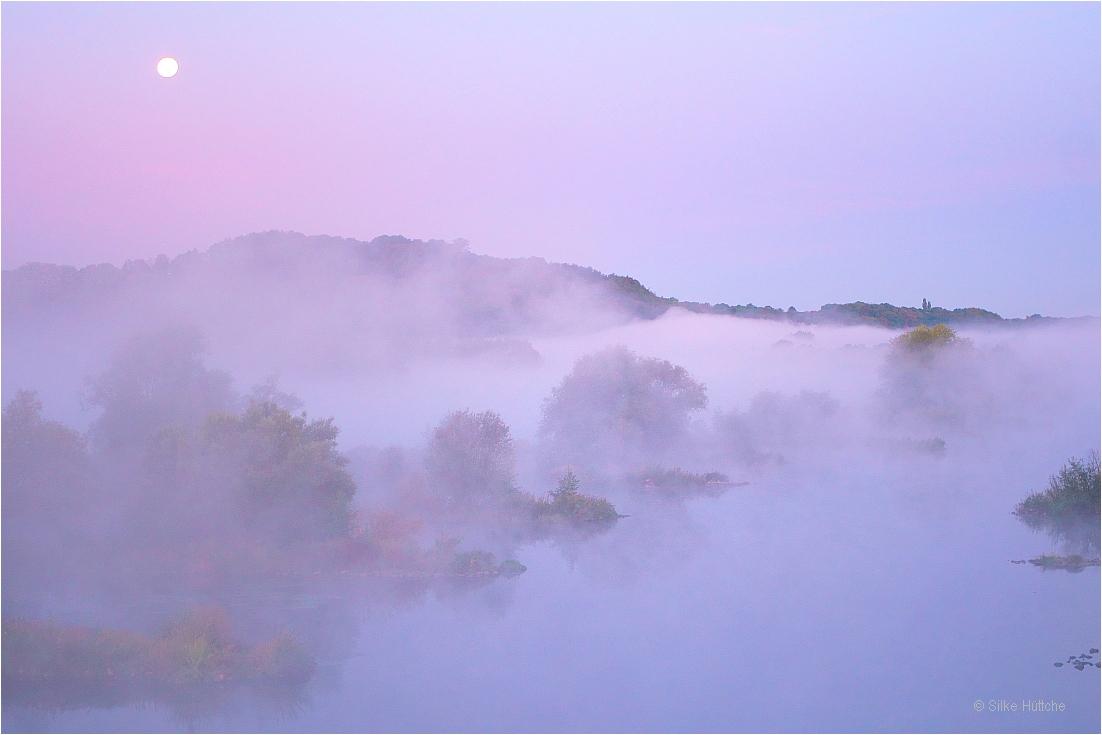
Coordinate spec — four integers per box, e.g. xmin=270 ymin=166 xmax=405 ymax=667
xmin=425 ymin=409 xmax=517 ymax=502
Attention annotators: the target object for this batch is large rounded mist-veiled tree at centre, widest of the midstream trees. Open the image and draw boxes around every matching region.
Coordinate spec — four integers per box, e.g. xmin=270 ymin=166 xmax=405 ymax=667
xmin=539 ymin=346 xmax=707 ymax=471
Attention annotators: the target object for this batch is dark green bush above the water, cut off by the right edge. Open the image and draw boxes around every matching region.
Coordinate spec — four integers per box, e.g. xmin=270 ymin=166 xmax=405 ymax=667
xmin=1014 ymin=451 xmax=1102 ymax=550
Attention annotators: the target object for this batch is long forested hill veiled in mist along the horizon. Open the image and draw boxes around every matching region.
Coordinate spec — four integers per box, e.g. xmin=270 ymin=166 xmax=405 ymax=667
xmin=3 ymin=231 xmax=1084 ymax=337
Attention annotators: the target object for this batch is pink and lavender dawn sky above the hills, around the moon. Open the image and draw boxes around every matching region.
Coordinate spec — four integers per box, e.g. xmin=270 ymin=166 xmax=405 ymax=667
xmin=0 ymin=2 xmax=1102 ymax=316
